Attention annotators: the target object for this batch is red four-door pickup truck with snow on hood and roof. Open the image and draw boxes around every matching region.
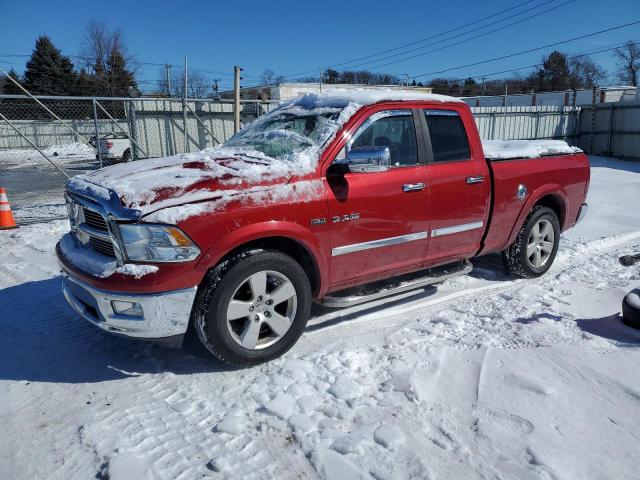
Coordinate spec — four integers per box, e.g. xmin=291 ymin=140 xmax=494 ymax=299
xmin=56 ymin=90 xmax=590 ymax=365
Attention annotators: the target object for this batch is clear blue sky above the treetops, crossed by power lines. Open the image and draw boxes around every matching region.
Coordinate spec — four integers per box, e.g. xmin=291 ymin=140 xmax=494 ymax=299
xmin=0 ymin=0 xmax=640 ymax=88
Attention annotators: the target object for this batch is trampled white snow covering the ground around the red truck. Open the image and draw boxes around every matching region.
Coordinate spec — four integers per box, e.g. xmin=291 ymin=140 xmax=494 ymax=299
xmin=0 ymin=157 xmax=640 ymax=480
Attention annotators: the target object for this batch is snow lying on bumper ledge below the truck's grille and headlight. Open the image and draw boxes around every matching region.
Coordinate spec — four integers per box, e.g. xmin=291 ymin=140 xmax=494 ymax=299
xmin=60 ymin=233 xmax=159 ymax=279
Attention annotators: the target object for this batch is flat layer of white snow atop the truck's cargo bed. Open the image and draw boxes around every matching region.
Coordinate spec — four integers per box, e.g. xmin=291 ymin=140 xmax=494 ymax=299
xmin=482 ymin=140 xmax=582 ymax=160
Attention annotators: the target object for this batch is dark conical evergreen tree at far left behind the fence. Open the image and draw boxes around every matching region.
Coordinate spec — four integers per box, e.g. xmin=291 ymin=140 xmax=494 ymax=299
xmin=24 ymin=35 xmax=76 ymax=95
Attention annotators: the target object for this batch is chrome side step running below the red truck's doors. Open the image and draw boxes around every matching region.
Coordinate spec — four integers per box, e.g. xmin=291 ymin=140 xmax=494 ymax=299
xmin=317 ymin=261 xmax=473 ymax=308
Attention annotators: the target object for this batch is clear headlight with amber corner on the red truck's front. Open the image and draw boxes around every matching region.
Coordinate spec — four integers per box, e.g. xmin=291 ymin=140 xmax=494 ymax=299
xmin=119 ymin=223 xmax=200 ymax=262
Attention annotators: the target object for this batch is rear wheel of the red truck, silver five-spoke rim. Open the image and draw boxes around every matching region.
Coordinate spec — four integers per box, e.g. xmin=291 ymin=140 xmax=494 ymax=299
xmin=502 ymin=206 xmax=560 ymax=278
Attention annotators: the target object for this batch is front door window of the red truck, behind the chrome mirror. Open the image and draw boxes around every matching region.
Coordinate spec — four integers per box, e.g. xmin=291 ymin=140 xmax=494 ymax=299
xmin=338 ymin=110 xmax=418 ymax=167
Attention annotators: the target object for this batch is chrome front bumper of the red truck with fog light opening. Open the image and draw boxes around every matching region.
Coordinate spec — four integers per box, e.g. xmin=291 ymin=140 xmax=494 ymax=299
xmin=62 ymin=270 xmax=197 ymax=345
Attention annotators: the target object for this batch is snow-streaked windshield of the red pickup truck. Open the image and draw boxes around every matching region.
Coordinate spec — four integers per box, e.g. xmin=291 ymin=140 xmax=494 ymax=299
xmin=223 ymin=106 xmax=342 ymax=160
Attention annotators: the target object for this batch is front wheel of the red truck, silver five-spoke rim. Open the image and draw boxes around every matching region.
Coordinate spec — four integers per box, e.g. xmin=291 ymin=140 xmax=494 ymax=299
xmin=194 ymin=250 xmax=311 ymax=367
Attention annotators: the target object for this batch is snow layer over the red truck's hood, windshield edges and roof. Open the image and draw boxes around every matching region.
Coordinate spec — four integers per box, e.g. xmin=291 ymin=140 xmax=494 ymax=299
xmin=69 ymin=88 xmax=459 ymax=218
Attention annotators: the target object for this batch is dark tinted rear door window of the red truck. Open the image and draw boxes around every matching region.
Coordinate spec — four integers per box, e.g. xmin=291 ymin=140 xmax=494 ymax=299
xmin=423 ymin=110 xmax=471 ymax=162
